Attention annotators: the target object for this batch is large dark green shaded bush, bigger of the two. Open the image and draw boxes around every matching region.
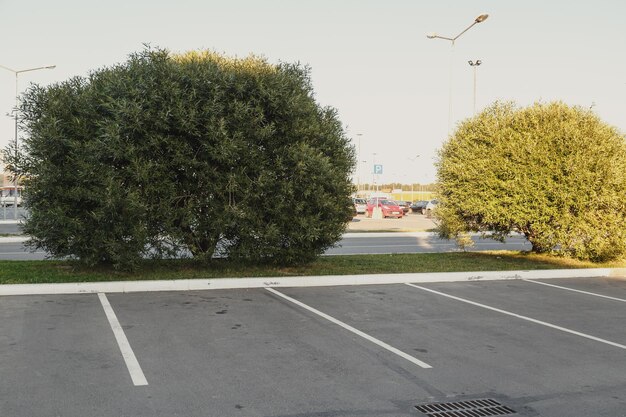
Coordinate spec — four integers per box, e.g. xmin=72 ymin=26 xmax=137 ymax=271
xmin=14 ymin=49 xmax=354 ymax=268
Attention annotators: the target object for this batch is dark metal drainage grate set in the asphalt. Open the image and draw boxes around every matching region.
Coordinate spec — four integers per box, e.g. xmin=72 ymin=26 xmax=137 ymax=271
xmin=415 ymin=398 xmax=516 ymax=417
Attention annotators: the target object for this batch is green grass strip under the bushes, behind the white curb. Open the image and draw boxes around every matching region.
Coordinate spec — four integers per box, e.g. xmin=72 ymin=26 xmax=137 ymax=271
xmin=0 ymin=251 xmax=626 ymax=284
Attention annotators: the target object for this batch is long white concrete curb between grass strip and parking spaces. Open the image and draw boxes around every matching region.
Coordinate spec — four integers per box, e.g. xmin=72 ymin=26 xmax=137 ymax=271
xmin=0 ymin=268 xmax=626 ymax=296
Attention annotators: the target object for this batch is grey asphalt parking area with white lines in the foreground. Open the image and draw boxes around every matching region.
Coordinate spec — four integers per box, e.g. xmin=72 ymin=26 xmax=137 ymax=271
xmin=0 ymin=278 xmax=626 ymax=417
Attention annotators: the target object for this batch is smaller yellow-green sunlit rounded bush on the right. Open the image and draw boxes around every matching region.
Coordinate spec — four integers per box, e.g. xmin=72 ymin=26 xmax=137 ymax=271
xmin=437 ymin=102 xmax=626 ymax=261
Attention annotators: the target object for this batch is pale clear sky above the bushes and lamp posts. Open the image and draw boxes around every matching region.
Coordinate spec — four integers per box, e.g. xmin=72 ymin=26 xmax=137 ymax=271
xmin=0 ymin=0 xmax=626 ymax=183
